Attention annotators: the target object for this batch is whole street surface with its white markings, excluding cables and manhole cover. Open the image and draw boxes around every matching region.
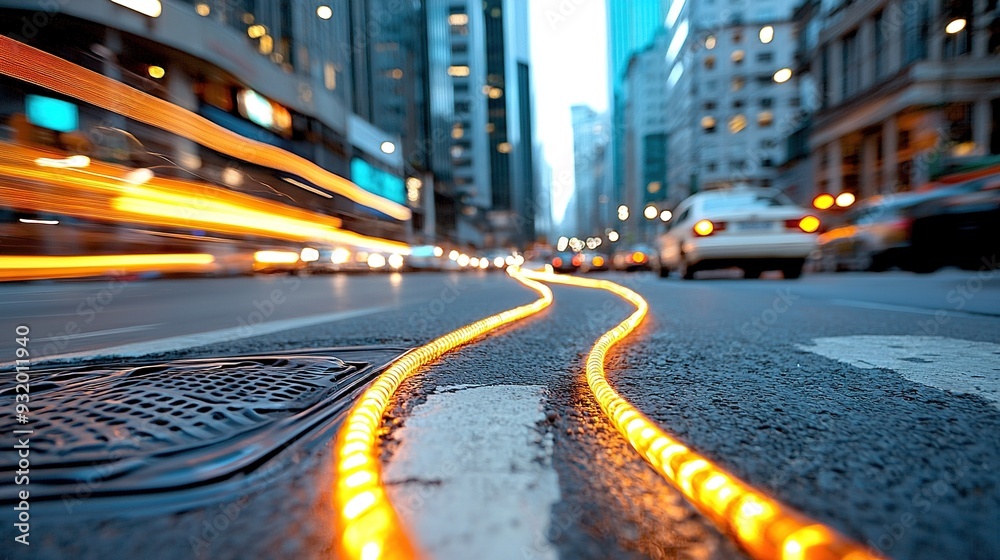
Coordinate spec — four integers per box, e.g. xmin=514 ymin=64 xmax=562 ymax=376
xmin=0 ymin=270 xmax=1000 ymax=559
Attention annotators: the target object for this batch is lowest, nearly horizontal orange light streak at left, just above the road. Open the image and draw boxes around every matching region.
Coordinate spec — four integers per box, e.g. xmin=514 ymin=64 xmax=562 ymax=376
xmin=0 ymin=253 xmax=215 ymax=281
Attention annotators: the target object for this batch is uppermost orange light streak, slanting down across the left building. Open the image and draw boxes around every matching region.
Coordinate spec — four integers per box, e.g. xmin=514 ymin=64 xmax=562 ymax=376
xmin=0 ymin=36 xmax=412 ymax=220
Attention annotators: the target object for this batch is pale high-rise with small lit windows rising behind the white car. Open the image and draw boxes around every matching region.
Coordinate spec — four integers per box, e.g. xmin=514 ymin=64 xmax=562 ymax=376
xmin=648 ymin=0 xmax=802 ymax=204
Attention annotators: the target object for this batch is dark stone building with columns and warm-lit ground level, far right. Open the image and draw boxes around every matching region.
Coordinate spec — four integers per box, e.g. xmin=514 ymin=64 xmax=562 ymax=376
xmin=797 ymin=0 xmax=1000 ymax=199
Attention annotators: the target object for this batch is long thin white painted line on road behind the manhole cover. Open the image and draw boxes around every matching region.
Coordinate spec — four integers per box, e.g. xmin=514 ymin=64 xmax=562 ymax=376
xmin=13 ymin=307 xmax=392 ymax=366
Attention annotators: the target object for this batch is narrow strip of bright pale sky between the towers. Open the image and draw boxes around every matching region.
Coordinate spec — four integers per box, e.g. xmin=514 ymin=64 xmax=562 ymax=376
xmin=530 ymin=0 xmax=604 ymax=231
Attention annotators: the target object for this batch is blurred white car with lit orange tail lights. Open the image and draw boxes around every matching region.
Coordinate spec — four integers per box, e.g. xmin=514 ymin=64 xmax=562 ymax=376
xmin=654 ymin=187 xmax=820 ymax=280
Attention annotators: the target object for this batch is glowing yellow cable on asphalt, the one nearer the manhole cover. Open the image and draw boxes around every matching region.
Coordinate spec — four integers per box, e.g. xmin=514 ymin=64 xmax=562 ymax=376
xmin=334 ymin=271 xmax=552 ymax=560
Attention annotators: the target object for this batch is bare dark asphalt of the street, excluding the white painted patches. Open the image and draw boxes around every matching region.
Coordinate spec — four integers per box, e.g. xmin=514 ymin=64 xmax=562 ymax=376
xmin=0 ymin=270 xmax=1000 ymax=559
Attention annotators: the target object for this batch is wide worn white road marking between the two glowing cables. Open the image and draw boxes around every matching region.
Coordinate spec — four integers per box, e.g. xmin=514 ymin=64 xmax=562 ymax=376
xmin=384 ymin=385 xmax=559 ymax=560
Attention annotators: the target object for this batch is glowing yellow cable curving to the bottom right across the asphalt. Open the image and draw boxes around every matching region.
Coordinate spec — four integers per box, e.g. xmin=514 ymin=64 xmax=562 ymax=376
xmin=514 ymin=270 xmax=879 ymax=560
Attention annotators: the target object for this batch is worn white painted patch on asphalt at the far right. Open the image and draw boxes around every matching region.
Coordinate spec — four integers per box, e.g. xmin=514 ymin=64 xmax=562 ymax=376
xmin=799 ymin=336 xmax=1000 ymax=408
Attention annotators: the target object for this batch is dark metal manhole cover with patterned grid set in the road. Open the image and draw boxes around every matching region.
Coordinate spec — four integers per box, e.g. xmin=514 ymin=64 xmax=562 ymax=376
xmin=0 ymin=348 xmax=405 ymax=499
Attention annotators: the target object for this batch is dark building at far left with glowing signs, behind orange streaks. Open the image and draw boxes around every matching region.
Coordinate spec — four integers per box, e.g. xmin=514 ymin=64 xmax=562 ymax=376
xmin=0 ymin=0 xmax=412 ymax=246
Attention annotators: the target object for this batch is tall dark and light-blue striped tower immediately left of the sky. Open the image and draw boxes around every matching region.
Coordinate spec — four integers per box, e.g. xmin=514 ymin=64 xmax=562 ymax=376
xmin=431 ymin=0 xmax=537 ymax=247
